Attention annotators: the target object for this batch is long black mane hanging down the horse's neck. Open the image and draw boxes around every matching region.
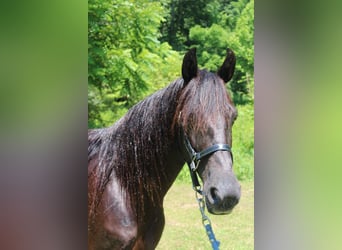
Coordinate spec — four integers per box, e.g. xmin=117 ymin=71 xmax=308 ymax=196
xmin=88 ymin=78 xmax=183 ymax=223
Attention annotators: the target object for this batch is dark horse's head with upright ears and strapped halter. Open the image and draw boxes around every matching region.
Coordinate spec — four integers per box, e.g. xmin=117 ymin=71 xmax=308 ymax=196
xmin=177 ymin=49 xmax=241 ymax=214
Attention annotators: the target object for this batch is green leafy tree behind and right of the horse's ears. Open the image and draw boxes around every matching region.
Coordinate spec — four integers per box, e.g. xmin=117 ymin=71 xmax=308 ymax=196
xmin=189 ymin=0 xmax=254 ymax=104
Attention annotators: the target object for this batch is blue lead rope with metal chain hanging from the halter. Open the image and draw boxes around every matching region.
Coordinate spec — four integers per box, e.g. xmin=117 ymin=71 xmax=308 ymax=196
xmin=189 ymin=165 xmax=220 ymax=250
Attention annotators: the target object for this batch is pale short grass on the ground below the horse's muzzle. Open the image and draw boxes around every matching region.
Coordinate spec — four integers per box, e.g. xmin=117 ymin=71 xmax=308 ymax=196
xmin=157 ymin=181 xmax=254 ymax=250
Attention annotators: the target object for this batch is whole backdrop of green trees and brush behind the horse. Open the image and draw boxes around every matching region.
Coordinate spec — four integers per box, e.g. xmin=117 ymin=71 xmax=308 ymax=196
xmin=88 ymin=0 xmax=254 ymax=180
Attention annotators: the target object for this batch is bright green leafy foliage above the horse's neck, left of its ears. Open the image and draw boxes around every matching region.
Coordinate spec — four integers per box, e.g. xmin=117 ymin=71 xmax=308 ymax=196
xmin=88 ymin=0 xmax=181 ymax=127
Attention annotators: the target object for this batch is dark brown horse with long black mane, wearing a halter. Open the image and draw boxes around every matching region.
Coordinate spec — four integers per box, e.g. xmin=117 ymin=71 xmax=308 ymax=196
xmin=88 ymin=48 xmax=241 ymax=250
